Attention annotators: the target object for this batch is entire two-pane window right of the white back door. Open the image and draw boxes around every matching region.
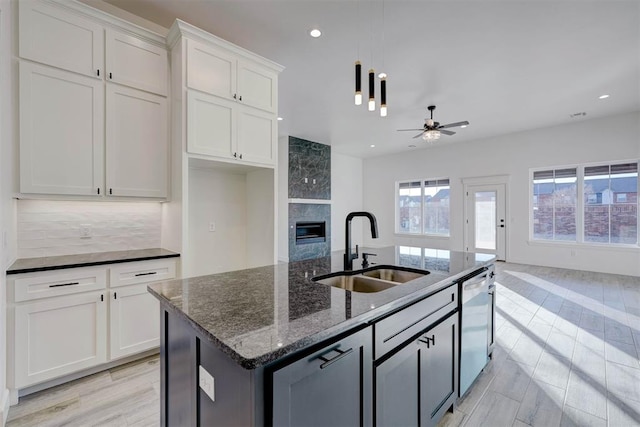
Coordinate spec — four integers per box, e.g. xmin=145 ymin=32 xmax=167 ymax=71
xmin=532 ymin=162 xmax=638 ymax=245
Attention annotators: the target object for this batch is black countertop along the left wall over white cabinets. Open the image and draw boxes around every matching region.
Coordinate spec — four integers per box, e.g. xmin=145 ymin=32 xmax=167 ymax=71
xmin=7 ymin=248 xmax=180 ymax=274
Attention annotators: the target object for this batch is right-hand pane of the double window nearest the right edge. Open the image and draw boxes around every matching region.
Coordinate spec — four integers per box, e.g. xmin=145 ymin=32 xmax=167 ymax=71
xmin=584 ymin=163 xmax=638 ymax=244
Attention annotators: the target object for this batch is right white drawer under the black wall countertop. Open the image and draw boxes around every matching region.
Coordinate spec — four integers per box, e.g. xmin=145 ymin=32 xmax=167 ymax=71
xmin=109 ymin=260 xmax=176 ymax=288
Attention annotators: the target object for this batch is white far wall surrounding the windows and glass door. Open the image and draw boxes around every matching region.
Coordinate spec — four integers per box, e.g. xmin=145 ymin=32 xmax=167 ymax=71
xmin=364 ymin=112 xmax=640 ymax=276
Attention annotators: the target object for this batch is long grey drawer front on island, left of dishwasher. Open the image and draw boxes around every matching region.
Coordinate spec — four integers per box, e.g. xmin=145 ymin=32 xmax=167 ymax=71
xmin=374 ymin=284 xmax=458 ymax=359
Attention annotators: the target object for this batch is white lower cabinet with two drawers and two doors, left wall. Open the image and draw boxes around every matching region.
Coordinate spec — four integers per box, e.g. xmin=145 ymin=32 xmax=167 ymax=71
xmin=7 ymin=259 xmax=176 ymax=398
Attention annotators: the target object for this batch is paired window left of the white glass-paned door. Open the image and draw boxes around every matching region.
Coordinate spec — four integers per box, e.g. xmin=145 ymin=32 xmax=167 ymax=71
xmin=397 ymin=179 xmax=450 ymax=236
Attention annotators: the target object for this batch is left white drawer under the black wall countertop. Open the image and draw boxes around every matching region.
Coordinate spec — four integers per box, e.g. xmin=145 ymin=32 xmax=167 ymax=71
xmin=13 ymin=268 xmax=107 ymax=302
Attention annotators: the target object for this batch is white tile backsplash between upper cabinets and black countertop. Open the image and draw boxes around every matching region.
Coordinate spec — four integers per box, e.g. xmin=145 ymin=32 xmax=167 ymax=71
xmin=17 ymin=200 xmax=162 ymax=258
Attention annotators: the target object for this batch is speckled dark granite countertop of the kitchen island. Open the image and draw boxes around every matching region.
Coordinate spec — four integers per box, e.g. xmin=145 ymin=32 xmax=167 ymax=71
xmin=148 ymin=246 xmax=495 ymax=369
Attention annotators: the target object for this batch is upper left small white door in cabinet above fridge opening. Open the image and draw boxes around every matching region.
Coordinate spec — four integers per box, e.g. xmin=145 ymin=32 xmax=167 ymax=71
xmin=187 ymin=40 xmax=237 ymax=99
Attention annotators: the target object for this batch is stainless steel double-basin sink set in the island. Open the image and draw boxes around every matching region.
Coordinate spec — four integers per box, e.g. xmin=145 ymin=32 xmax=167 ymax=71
xmin=311 ymin=265 xmax=429 ymax=293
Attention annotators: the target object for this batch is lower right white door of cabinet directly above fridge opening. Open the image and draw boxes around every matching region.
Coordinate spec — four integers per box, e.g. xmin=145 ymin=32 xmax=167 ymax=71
xmin=237 ymin=106 xmax=278 ymax=165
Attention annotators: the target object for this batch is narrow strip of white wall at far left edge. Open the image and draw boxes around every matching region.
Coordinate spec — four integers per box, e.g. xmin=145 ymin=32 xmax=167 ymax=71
xmin=0 ymin=0 xmax=17 ymax=425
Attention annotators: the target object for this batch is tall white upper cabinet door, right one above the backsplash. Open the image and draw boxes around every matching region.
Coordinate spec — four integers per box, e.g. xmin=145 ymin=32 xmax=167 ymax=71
xmin=106 ymin=84 xmax=169 ymax=197
